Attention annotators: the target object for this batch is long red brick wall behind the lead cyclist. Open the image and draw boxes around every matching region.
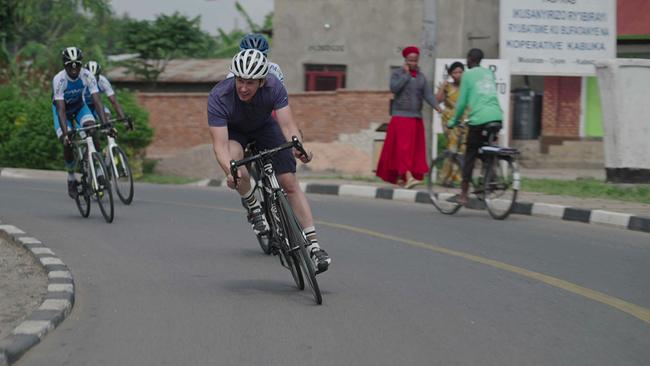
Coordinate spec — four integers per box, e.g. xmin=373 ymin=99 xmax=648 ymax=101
xmin=138 ymin=91 xmax=391 ymax=158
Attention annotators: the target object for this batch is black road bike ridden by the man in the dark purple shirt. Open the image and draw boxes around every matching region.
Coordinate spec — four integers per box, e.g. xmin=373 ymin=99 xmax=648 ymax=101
xmin=230 ymin=137 xmax=323 ymax=305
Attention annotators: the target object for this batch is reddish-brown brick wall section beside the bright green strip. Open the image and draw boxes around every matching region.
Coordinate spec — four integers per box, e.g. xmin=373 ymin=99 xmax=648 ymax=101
xmin=542 ymin=76 xmax=582 ymax=137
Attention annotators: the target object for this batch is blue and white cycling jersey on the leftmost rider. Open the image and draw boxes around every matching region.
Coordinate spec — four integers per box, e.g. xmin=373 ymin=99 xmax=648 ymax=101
xmin=52 ymin=69 xmax=99 ymax=116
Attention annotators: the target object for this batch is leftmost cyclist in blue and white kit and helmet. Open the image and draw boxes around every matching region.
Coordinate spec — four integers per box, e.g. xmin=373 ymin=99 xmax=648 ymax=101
xmin=52 ymin=47 xmax=106 ymax=198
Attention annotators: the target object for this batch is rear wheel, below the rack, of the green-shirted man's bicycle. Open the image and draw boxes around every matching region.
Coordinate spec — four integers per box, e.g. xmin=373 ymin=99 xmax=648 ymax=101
xmin=483 ymin=156 xmax=520 ymax=220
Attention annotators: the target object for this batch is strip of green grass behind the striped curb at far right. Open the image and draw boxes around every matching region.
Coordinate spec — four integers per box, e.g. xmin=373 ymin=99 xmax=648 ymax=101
xmin=521 ymin=178 xmax=650 ymax=203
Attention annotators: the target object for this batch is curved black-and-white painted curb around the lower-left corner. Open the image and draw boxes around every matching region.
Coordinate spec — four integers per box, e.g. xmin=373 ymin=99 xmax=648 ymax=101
xmin=0 ymin=225 xmax=75 ymax=366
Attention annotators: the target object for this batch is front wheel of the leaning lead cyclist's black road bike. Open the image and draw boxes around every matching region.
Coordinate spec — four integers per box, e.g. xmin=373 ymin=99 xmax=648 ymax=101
xmin=277 ymin=191 xmax=323 ymax=305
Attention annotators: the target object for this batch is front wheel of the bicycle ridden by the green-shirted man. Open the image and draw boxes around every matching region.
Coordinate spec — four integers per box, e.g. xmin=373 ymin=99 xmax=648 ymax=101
xmin=427 ymin=154 xmax=462 ymax=215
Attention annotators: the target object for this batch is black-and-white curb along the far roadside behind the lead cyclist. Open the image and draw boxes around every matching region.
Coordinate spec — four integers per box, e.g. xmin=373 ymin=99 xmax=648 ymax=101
xmin=195 ymin=179 xmax=650 ymax=233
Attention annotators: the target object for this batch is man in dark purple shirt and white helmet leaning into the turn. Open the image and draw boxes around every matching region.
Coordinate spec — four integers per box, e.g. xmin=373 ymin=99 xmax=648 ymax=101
xmin=208 ymin=49 xmax=331 ymax=273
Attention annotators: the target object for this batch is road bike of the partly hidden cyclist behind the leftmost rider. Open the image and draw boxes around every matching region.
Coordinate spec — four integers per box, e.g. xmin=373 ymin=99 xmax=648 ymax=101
xmin=100 ymin=117 xmax=133 ymax=205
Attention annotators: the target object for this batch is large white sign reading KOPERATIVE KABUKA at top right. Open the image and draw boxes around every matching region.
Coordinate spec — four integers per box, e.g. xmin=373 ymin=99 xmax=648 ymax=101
xmin=499 ymin=0 xmax=616 ymax=76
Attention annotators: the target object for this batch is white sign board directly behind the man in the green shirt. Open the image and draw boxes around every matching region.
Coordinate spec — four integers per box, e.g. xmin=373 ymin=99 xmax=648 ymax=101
xmin=433 ymin=58 xmax=510 ymax=152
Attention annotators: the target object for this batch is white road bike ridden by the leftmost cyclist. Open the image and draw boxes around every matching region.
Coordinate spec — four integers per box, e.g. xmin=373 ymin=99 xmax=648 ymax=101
xmin=68 ymin=123 xmax=114 ymax=223
